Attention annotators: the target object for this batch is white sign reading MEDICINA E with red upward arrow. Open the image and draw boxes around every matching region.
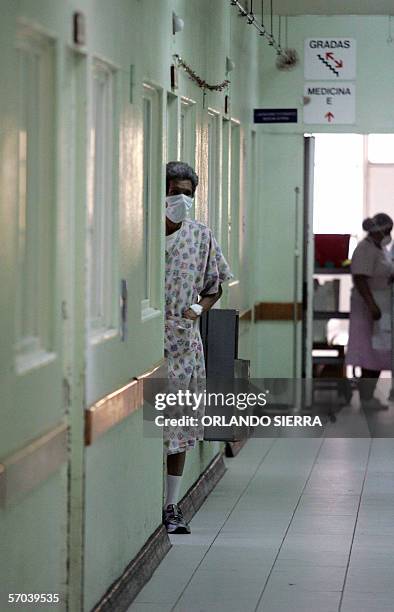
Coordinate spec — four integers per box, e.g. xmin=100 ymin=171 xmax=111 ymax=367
xmin=304 ymin=81 xmax=356 ymax=125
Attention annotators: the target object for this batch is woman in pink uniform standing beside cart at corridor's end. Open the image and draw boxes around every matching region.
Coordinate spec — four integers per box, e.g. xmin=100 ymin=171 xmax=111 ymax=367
xmin=346 ymin=213 xmax=394 ymax=409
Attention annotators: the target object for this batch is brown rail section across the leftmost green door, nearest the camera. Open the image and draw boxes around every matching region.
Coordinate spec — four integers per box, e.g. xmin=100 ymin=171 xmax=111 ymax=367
xmin=0 ymin=423 xmax=68 ymax=506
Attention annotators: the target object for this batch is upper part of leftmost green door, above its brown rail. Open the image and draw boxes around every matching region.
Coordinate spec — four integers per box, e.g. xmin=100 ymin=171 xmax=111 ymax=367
xmin=0 ymin=14 xmax=64 ymax=454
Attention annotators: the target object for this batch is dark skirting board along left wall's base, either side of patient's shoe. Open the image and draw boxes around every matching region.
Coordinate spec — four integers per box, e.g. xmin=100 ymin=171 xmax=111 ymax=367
xmin=92 ymin=453 xmax=226 ymax=612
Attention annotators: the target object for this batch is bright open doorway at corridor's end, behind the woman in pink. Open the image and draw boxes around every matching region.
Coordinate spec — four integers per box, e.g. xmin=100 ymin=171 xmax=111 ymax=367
xmin=304 ymin=134 xmax=394 ymax=388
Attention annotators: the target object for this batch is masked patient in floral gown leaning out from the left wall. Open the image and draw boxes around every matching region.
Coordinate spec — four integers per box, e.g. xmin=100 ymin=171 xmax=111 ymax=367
xmin=163 ymin=162 xmax=232 ymax=533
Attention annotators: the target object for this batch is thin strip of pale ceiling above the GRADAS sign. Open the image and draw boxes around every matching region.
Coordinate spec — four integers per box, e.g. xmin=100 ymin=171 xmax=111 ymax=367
xmin=252 ymin=0 xmax=394 ymax=15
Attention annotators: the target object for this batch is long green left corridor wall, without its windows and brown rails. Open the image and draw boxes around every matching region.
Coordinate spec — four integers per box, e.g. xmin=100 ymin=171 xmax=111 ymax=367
xmin=0 ymin=0 xmax=261 ymax=612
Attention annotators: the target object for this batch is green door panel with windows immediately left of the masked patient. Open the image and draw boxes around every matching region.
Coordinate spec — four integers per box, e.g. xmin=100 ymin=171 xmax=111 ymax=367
xmin=83 ymin=9 xmax=167 ymax=610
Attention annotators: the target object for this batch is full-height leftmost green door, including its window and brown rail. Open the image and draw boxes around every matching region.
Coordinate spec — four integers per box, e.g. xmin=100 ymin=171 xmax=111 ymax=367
xmin=0 ymin=2 xmax=67 ymax=610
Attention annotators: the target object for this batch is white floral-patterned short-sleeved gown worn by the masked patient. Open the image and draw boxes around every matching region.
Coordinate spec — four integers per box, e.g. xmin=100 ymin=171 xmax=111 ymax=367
xmin=164 ymin=219 xmax=233 ymax=454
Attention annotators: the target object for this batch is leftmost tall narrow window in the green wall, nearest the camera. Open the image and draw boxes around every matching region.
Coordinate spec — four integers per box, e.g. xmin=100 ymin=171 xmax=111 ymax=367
xmin=15 ymin=31 xmax=56 ymax=371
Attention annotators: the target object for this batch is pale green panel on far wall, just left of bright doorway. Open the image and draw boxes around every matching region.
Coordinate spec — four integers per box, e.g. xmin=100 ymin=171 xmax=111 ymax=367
xmin=255 ymin=133 xmax=304 ymax=378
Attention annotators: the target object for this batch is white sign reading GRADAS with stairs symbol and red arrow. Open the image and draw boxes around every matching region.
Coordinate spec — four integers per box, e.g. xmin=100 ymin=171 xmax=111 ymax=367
xmin=304 ymin=38 xmax=356 ymax=81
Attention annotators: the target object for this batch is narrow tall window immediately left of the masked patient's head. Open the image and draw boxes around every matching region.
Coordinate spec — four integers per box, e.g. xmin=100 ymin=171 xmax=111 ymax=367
xmin=141 ymin=84 xmax=163 ymax=319
